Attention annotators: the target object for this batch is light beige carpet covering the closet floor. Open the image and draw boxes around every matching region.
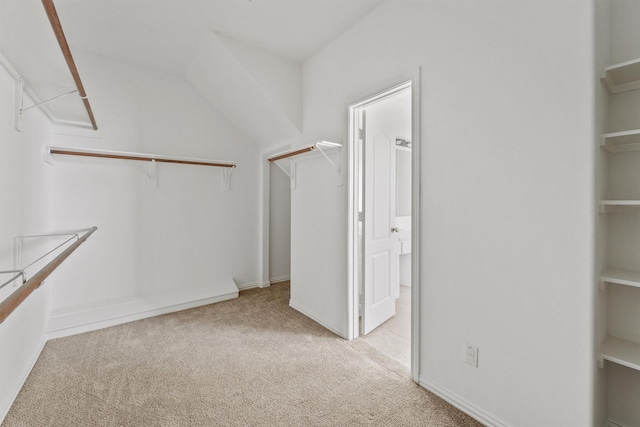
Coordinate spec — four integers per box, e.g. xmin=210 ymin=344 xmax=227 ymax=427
xmin=3 ymin=283 xmax=480 ymax=427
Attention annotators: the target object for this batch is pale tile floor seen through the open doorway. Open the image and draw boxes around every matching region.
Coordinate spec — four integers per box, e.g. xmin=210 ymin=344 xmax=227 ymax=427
xmin=362 ymin=286 xmax=411 ymax=368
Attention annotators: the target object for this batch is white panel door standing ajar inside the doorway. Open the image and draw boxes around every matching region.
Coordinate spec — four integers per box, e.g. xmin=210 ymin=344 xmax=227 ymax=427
xmin=363 ymin=129 xmax=398 ymax=335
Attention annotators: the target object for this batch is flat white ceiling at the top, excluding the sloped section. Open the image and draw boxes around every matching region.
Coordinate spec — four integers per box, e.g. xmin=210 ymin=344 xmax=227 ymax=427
xmin=55 ymin=0 xmax=383 ymax=75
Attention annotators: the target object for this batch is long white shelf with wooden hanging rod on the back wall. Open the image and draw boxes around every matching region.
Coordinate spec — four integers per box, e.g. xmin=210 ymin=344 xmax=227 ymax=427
xmin=46 ymin=146 xmax=236 ymax=191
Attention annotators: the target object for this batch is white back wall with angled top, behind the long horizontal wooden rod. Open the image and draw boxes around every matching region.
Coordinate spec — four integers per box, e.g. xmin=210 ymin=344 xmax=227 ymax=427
xmin=44 ymin=53 xmax=259 ymax=331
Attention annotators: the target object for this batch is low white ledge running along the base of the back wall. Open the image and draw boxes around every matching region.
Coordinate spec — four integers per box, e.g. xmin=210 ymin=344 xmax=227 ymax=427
xmin=47 ymin=280 xmax=238 ymax=339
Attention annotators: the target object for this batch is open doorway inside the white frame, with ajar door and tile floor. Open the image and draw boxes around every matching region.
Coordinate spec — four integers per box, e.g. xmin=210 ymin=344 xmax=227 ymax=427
xmin=350 ymin=82 xmax=417 ymax=367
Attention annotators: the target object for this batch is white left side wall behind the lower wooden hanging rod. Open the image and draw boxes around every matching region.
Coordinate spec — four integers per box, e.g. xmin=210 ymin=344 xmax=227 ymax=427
xmin=0 ymin=58 xmax=54 ymax=422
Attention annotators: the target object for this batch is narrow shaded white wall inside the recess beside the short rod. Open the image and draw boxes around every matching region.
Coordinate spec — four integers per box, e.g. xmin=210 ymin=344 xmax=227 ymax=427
xmin=269 ymin=163 xmax=291 ymax=282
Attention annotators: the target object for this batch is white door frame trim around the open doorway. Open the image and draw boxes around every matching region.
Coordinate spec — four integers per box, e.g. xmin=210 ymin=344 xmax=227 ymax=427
xmin=347 ymin=68 xmax=421 ymax=382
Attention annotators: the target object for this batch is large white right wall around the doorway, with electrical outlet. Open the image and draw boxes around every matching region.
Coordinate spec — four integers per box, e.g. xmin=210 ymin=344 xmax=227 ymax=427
xmin=291 ymin=0 xmax=594 ymax=427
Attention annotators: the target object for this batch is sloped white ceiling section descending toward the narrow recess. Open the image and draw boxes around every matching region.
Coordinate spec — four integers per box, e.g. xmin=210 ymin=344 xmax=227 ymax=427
xmin=186 ymin=32 xmax=302 ymax=149
